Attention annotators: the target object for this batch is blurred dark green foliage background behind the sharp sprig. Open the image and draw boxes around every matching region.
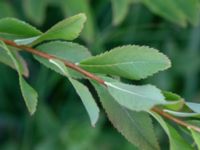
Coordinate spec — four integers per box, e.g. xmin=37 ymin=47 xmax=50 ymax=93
xmin=0 ymin=0 xmax=200 ymax=150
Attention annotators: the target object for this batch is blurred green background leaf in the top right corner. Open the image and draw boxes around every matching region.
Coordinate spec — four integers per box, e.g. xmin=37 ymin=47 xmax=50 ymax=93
xmin=142 ymin=0 xmax=200 ymax=26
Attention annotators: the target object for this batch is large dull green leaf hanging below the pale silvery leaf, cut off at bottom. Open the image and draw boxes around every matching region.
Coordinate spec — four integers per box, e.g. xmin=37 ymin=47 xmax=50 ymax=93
xmin=92 ymin=82 xmax=159 ymax=150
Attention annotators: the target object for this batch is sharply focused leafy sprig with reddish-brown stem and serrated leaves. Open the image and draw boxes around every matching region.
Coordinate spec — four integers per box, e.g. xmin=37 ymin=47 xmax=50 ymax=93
xmin=0 ymin=14 xmax=200 ymax=150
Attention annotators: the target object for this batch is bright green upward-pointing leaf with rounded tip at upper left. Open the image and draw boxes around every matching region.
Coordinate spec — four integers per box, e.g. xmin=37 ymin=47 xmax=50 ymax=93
xmin=32 ymin=13 xmax=86 ymax=45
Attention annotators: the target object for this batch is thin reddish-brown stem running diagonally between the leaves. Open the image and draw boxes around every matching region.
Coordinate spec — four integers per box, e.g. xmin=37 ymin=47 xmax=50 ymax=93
xmin=0 ymin=38 xmax=200 ymax=132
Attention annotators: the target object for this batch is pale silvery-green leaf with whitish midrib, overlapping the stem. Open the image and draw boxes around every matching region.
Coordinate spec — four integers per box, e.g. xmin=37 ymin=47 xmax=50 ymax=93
xmin=105 ymin=82 xmax=166 ymax=111
